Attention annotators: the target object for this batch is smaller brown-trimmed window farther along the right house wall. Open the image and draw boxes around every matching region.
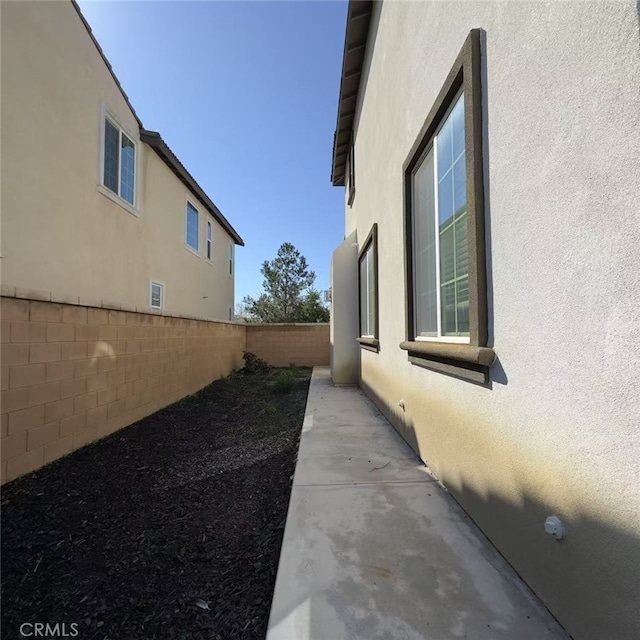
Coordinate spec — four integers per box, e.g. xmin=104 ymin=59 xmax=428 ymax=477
xmin=358 ymin=224 xmax=379 ymax=351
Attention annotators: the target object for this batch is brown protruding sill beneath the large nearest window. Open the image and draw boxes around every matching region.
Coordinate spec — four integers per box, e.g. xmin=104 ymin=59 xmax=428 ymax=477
xmin=400 ymin=340 xmax=496 ymax=384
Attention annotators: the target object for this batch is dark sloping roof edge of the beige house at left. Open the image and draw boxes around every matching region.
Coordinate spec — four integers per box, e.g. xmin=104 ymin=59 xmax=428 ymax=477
xmin=71 ymin=0 xmax=244 ymax=247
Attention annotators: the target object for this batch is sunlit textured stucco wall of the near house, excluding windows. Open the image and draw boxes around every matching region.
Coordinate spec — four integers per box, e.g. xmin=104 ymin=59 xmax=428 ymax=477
xmin=346 ymin=1 xmax=640 ymax=640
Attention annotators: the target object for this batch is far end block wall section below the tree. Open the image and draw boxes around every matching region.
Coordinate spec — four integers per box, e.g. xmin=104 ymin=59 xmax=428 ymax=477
xmin=246 ymin=323 xmax=330 ymax=367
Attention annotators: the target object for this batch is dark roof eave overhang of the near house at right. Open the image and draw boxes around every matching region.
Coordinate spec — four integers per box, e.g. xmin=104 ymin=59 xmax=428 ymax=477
xmin=331 ymin=0 xmax=374 ymax=187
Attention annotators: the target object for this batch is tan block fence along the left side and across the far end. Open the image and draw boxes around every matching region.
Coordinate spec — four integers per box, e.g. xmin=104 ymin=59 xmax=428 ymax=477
xmin=0 ymin=297 xmax=329 ymax=483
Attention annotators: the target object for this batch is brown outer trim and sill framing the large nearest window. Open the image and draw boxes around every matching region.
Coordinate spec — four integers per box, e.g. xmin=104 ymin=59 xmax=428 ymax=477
xmin=400 ymin=29 xmax=495 ymax=384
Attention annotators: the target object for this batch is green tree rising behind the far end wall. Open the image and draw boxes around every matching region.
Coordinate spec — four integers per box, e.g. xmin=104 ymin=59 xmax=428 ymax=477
xmin=242 ymin=242 xmax=329 ymax=322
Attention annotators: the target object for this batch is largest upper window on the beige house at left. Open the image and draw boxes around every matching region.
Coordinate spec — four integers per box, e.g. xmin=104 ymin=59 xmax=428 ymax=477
xmin=102 ymin=116 xmax=136 ymax=205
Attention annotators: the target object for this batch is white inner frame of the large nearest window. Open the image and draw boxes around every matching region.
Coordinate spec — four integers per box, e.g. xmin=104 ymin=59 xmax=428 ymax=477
xmin=411 ymin=88 xmax=471 ymax=344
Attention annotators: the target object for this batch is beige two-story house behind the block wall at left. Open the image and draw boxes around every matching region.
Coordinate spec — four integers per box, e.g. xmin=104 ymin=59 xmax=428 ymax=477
xmin=1 ymin=1 xmax=243 ymax=320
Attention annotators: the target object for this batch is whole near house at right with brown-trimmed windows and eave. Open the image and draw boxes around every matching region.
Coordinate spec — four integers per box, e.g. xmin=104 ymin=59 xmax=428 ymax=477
xmin=331 ymin=0 xmax=640 ymax=640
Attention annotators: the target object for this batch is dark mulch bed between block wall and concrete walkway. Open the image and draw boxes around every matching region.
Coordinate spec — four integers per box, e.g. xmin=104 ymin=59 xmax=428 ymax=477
xmin=1 ymin=368 xmax=311 ymax=640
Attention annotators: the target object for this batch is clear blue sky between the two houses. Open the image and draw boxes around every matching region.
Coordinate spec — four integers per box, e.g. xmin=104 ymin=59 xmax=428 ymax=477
xmin=79 ymin=0 xmax=347 ymax=303
